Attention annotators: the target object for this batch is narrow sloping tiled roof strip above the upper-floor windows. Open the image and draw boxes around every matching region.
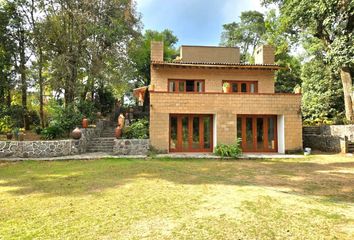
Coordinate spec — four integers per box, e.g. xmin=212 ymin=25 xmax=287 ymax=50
xmin=151 ymin=60 xmax=286 ymax=70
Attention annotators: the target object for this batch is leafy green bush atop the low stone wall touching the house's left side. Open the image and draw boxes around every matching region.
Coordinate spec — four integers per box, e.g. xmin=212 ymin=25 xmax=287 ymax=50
xmin=123 ymin=118 xmax=149 ymax=139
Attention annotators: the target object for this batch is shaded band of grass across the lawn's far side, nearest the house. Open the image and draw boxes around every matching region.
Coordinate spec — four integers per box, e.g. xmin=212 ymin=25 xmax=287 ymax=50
xmin=0 ymin=159 xmax=354 ymax=203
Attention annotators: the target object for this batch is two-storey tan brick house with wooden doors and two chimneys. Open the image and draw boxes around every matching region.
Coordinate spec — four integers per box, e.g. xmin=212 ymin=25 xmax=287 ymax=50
xmin=144 ymin=42 xmax=302 ymax=153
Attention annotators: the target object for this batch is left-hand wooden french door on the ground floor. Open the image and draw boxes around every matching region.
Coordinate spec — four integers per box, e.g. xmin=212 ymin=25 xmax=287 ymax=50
xmin=169 ymin=114 xmax=213 ymax=152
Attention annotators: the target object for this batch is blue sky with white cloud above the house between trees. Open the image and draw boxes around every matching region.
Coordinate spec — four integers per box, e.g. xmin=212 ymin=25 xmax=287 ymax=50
xmin=136 ymin=0 xmax=265 ymax=46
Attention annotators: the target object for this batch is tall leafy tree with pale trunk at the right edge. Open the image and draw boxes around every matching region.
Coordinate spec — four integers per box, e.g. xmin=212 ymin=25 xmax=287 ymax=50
xmin=263 ymin=0 xmax=354 ymax=120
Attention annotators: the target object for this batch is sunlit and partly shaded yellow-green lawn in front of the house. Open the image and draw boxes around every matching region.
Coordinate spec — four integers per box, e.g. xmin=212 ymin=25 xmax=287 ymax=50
xmin=0 ymin=155 xmax=354 ymax=239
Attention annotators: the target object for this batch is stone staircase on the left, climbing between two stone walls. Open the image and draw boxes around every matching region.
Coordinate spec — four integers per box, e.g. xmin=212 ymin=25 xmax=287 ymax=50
xmin=87 ymin=122 xmax=115 ymax=153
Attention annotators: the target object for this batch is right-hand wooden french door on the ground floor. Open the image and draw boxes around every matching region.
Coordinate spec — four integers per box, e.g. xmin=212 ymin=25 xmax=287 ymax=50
xmin=237 ymin=115 xmax=278 ymax=152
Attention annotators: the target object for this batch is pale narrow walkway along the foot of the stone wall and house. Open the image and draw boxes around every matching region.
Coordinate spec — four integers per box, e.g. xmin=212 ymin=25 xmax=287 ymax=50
xmin=0 ymin=152 xmax=304 ymax=161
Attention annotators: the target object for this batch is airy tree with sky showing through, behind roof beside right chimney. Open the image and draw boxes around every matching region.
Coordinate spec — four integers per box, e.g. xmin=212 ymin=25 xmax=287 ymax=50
xmin=221 ymin=11 xmax=266 ymax=62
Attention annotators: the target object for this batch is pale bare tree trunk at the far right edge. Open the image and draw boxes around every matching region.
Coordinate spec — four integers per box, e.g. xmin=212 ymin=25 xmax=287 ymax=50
xmin=340 ymin=67 xmax=354 ymax=121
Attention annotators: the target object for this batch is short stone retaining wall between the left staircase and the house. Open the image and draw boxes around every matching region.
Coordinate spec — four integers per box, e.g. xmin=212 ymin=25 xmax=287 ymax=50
xmin=113 ymin=139 xmax=150 ymax=155
